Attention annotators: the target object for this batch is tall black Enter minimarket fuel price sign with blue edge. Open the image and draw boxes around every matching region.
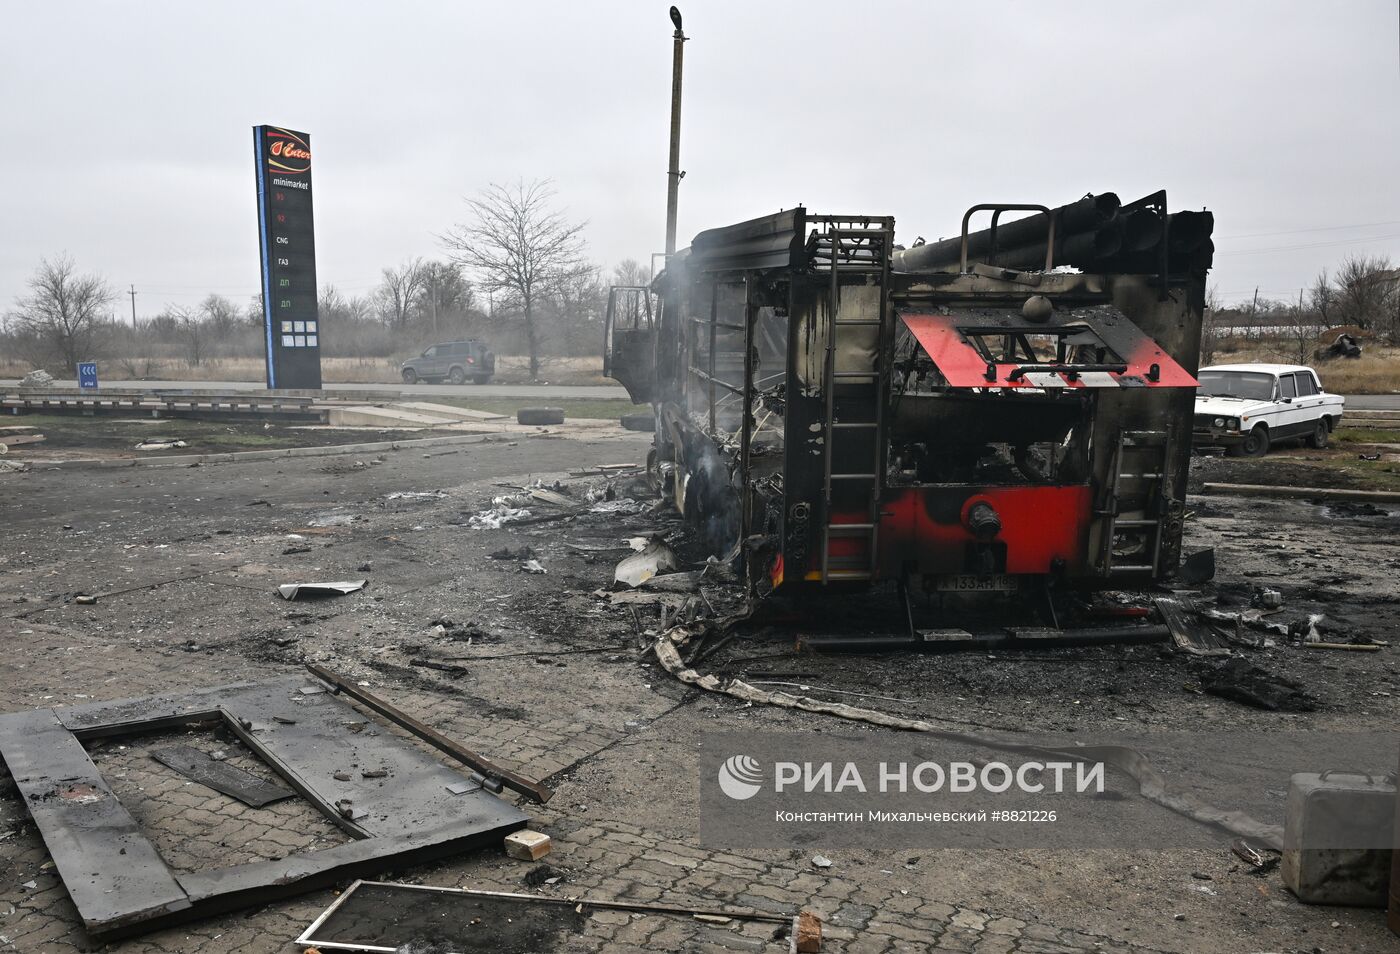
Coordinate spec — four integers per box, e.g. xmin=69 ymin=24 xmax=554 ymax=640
xmin=253 ymin=126 xmax=322 ymax=389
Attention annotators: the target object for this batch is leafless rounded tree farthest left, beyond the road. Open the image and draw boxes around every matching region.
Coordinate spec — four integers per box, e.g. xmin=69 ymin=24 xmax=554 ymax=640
xmin=10 ymin=255 xmax=113 ymax=374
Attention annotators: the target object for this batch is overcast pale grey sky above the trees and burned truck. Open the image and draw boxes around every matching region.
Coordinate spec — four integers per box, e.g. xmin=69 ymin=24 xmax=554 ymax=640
xmin=0 ymin=0 xmax=1400 ymax=314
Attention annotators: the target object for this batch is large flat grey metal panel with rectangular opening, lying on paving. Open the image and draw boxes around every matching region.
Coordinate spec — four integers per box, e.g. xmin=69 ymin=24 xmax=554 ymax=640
xmin=0 ymin=677 xmax=529 ymax=939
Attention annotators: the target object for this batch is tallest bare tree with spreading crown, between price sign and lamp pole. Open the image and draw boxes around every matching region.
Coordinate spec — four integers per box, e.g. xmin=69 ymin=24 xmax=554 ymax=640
xmin=442 ymin=179 xmax=584 ymax=380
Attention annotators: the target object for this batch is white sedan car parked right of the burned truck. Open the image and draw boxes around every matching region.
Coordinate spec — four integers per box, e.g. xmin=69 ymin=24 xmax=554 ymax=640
xmin=1191 ymin=364 xmax=1345 ymax=457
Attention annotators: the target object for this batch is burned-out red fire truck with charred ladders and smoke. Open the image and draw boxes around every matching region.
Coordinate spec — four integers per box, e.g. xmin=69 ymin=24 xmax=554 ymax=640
xmin=605 ymin=192 xmax=1214 ymax=602
